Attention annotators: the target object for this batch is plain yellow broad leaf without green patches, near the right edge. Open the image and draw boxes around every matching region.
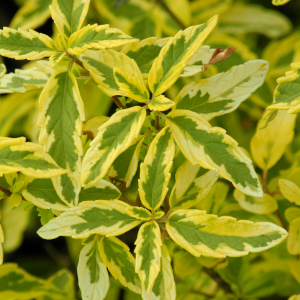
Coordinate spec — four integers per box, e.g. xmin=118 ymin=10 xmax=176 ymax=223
xmin=250 ymin=111 xmax=296 ymax=170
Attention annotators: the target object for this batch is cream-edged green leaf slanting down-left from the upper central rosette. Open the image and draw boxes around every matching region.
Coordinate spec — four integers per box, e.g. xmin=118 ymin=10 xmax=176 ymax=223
xmin=81 ymin=106 xmax=146 ymax=186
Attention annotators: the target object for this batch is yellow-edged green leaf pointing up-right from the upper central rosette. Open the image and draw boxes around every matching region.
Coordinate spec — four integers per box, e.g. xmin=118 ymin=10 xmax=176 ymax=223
xmin=148 ymin=16 xmax=218 ymax=96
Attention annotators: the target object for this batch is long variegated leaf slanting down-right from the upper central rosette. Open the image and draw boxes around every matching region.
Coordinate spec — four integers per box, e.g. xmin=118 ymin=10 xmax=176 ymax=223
xmin=166 ymin=110 xmax=262 ymax=197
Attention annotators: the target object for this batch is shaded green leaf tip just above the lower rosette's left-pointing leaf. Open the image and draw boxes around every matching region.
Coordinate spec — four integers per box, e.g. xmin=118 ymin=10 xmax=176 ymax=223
xmin=79 ymin=179 xmax=121 ymax=202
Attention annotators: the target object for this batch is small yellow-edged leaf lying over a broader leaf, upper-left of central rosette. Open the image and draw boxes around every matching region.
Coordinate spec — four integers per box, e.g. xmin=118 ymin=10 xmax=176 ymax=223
xmin=113 ymin=65 xmax=149 ymax=103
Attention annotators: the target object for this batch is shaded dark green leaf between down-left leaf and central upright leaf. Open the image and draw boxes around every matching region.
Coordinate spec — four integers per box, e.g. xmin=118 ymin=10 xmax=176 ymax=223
xmin=108 ymin=137 xmax=144 ymax=190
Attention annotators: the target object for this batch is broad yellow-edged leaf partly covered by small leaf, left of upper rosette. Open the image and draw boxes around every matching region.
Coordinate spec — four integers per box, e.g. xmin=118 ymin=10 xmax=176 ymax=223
xmin=80 ymin=49 xmax=145 ymax=96
